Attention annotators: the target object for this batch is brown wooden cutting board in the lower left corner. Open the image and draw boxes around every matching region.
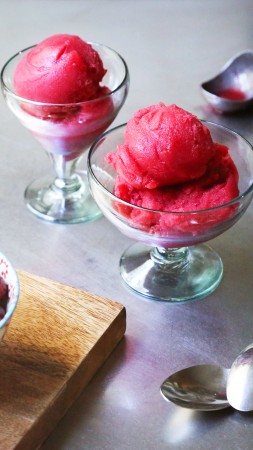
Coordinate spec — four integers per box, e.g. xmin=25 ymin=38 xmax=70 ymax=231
xmin=0 ymin=271 xmax=126 ymax=450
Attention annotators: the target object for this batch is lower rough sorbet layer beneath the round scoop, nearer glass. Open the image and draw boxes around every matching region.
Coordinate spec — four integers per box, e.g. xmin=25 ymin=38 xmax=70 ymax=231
xmin=114 ymin=144 xmax=239 ymax=235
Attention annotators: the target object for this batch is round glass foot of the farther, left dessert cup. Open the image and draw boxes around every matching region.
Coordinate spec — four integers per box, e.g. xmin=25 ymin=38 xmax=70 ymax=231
xmin=24 ymin=175 xmax=102 ymax=224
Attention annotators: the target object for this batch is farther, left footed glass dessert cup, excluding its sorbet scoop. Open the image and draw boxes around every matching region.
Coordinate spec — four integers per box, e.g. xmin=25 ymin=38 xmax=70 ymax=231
xmin=1 ymin=43 xmax=129 ymax=223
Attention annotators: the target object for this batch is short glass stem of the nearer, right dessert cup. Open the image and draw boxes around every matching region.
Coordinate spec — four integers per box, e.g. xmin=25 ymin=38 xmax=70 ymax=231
xmin=150 ymin=247 xmax=189 ymax=270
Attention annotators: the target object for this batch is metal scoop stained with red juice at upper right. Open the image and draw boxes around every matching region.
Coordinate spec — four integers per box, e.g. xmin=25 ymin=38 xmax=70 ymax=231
xmin=201 ymin=50 xmax=253 ymax=113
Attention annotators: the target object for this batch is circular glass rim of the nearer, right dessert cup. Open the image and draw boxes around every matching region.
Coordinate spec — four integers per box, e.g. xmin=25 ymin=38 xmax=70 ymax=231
xmin=87 ymin=119 xmax=253 ymax=215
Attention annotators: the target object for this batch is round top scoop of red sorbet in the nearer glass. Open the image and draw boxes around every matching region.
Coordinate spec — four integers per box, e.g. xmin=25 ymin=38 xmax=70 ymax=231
xmin=107 ymin=103 xmax=215 ymax=189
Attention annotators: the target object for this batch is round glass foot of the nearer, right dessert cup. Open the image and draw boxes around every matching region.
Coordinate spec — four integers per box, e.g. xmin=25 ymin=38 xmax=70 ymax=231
xmin=120 ymin=243 xmax=223 ymax=303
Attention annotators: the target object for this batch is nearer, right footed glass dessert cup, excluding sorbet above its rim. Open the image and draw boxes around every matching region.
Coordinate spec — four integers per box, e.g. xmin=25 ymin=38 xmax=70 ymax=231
xmin=88 ymin=122 xmax=253 ymax=302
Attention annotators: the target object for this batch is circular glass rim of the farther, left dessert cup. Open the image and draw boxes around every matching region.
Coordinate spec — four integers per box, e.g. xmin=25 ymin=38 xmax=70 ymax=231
xmin=0 ymin=41 xmax=129 ymax=106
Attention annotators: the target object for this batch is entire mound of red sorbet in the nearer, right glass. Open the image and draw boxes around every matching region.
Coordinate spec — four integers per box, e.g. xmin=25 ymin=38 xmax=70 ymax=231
xmin=106 ymin=103 xmax=239 ymax=233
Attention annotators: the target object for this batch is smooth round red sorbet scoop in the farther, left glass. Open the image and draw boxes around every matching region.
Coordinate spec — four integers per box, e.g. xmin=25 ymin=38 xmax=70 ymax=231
xmin=14 ymin=34 xmax=106 ymax=104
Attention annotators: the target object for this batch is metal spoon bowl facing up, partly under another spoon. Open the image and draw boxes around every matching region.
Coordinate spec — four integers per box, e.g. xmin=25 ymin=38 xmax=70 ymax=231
xmin=160 ymin=364 xmax=230 ymax=411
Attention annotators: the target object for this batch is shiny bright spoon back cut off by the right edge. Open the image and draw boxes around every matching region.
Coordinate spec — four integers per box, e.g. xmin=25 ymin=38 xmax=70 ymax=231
xmin=227 ymin=344 xmax=253 ymax=411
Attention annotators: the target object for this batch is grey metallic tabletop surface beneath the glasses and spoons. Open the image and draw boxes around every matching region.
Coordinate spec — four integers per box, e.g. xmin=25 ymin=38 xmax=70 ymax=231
xmin=0 ymin=0 xmax=253 ymax=450
